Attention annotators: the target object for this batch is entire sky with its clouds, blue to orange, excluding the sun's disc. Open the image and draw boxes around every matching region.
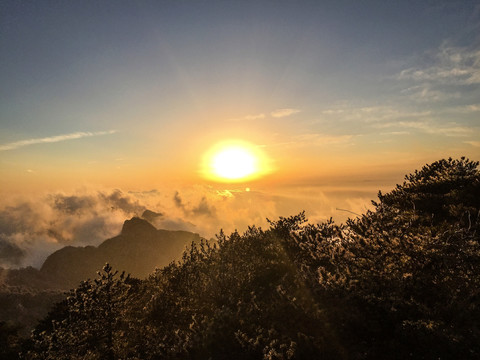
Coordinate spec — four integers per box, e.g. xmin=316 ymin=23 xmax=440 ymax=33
xmin=0 ymin=0 xmax=480 ymax=265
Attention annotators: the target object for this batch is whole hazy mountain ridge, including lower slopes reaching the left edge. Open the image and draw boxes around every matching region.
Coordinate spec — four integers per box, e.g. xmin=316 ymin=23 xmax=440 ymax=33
xmin=0 ymin=217 xmax=202 ymax=330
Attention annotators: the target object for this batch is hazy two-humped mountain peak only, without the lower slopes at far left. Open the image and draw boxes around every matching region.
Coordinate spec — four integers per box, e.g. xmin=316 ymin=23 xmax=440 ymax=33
xmin=40 ymin=217 xmax=201 ymax=287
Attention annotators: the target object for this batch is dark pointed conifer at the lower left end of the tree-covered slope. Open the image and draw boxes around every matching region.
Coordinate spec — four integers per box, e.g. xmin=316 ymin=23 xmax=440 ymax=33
xmin=25 ymin=264 xmax=135 ymax=360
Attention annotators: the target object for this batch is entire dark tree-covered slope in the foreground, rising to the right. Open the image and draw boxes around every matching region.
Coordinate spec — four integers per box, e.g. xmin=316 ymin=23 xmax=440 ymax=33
xmin=18 ymin=158 xmax=480 ymax=359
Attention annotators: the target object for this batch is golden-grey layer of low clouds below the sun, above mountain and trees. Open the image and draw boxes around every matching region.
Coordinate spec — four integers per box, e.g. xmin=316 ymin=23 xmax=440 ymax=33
xmin=0 ymin=186 xmax=376 ymax=268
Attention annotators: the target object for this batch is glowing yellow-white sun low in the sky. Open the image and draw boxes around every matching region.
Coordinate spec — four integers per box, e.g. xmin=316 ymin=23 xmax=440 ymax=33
xmin=201 ymin=140 xmax=272 ymax=182
